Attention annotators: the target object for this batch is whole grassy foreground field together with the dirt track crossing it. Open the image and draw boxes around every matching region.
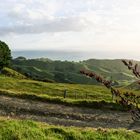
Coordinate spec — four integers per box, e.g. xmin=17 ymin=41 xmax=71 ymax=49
xmin=0 ymin=75 xmax=140 ymax=140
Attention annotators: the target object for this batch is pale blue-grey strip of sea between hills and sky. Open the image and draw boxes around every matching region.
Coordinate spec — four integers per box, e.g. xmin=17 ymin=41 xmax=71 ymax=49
xmin=11 ymin=50 xmax=140 ymax=61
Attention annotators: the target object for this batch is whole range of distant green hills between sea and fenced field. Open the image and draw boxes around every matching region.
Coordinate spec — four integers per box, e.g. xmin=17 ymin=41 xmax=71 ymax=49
xmin=12 ymin=57 xmax=139 ymax=85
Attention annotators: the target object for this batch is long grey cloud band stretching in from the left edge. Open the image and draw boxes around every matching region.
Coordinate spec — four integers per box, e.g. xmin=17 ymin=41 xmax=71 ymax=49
xmin=0 ymin=17 xmax=86 ymax=35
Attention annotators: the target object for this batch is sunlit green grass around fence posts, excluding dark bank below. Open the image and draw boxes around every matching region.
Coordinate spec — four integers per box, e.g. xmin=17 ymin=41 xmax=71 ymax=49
xmin=0 ymin=76 xmax=111 ymax=101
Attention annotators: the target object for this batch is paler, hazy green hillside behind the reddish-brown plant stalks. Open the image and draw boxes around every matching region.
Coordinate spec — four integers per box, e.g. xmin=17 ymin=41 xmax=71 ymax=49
xmin=83 ymin=59 xmax=138 ymax=81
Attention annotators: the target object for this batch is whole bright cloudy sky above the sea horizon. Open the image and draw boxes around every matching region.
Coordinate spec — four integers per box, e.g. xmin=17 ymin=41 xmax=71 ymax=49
xmin=0 ymin=0 xmax=140 ymax=59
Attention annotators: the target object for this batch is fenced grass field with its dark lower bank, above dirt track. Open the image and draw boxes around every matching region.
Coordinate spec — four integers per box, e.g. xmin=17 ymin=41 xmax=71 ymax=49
xmin=0 ymin=75 xmax=138 ymax=110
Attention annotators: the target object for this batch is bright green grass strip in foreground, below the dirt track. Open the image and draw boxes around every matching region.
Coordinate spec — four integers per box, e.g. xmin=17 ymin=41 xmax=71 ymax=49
xmin=0 ymin=118 xmax=140 ymax=140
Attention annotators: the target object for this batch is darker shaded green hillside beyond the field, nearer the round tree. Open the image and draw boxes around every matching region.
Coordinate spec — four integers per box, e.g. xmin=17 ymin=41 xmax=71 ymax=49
xmin=13 ymin=59 xmax=96 ymax=84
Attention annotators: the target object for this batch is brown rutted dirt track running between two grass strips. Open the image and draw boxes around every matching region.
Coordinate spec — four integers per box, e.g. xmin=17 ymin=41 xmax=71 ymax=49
xmin=0 ymin=96 xmax=140 ymax=129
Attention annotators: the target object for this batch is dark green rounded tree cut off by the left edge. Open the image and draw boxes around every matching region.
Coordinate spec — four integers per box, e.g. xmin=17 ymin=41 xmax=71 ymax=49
xmin=0 ymin=41 xmax=12 ymax=70
